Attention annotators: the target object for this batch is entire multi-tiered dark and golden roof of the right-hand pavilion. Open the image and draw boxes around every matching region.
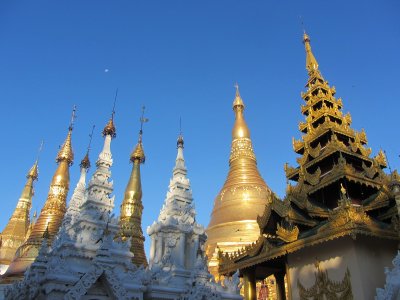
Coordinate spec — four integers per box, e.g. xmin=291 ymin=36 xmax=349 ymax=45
xmin=220 ymin=34 xmax=400 ymax=275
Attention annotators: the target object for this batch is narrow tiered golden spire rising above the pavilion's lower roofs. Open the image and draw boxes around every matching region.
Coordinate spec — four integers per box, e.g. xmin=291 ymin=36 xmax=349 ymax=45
xmin=285 ymin=33 xmax=387 ymax=211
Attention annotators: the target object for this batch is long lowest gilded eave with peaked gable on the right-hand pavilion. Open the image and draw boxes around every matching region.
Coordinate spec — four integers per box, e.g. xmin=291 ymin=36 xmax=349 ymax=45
xmin=219 ymin=205 xmax=399 ymax=274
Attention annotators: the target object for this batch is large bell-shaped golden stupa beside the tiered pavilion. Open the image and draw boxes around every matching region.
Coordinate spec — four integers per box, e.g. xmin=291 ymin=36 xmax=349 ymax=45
xmin=206 ymin=85 xmax=272 ymax=279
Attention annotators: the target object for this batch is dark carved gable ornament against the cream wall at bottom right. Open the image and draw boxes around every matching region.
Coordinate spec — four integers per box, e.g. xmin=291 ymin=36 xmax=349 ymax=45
xmin=297 ymin=267 xmax=354 ymax=300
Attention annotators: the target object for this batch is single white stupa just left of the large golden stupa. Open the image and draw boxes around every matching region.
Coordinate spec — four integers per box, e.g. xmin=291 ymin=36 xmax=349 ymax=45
xmin=146 ymin=135 xmax=242 ymax=299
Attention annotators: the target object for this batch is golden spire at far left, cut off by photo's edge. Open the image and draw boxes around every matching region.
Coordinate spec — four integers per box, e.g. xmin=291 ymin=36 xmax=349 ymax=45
xmin=0 ymin=160 xmax=38 ymax=274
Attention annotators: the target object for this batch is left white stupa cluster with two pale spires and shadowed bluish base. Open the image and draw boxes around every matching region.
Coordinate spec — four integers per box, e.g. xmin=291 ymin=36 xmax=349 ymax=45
xmin=5 ymin=127 xmax=145 ymax=299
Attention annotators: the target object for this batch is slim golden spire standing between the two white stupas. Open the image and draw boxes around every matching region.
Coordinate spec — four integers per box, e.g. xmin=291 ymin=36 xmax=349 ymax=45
xmin=117 ymin=110 xmax=147 ymax=267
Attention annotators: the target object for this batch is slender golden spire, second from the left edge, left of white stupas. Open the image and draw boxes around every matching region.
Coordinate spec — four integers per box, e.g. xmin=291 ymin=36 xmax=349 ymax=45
xmin=3 ymin=108 xmax=75 ymax=281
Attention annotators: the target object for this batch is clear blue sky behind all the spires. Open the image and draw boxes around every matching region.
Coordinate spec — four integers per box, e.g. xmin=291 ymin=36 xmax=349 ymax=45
xmin=0 ymin=0 xmax=400 ymax=256
